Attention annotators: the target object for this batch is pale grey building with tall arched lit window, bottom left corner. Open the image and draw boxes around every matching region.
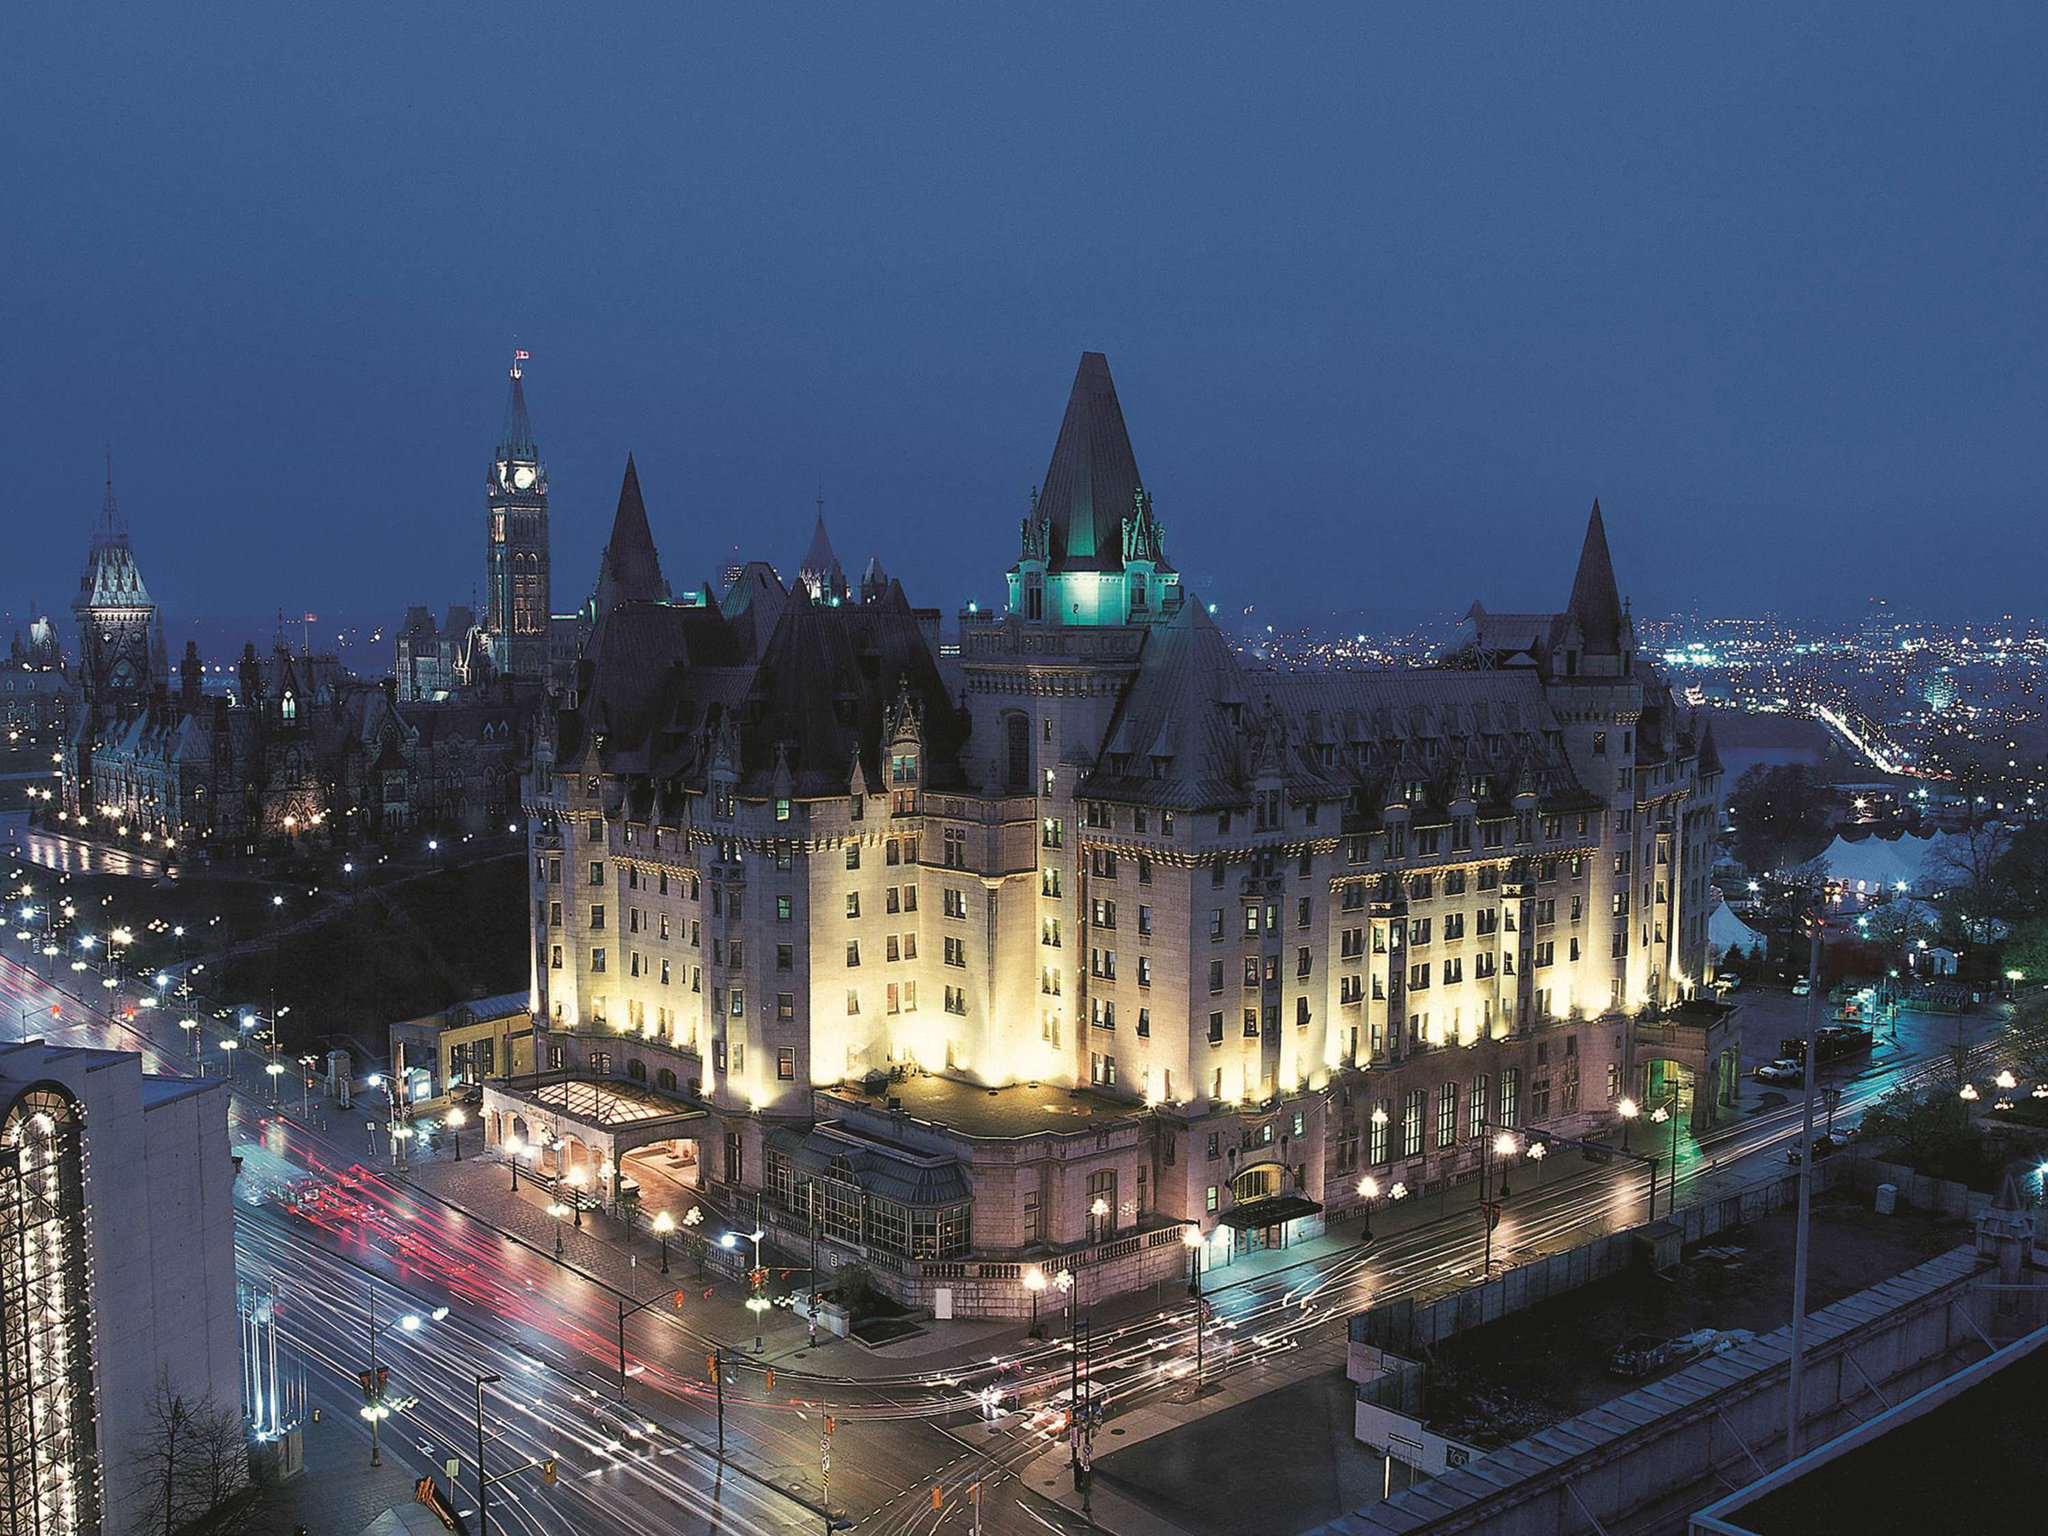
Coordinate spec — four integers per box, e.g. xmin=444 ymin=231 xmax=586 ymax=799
xmin=0 ymin=1040 xmax=242 ymax=1536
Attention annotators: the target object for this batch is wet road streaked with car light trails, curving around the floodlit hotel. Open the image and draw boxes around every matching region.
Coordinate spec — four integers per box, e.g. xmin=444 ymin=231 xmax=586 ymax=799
xmin=0 ymin=843 xmax=1998 ymax=1532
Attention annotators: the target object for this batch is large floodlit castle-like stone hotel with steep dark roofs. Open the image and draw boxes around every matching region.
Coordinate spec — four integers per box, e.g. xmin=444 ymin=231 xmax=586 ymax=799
xmin=489 ymin=354 xmax=1735 ymax=1315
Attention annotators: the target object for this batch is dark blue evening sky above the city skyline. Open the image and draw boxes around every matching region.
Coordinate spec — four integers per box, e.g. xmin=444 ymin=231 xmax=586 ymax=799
xmin=0 ymin=2 xmax=2048 ymax=625
